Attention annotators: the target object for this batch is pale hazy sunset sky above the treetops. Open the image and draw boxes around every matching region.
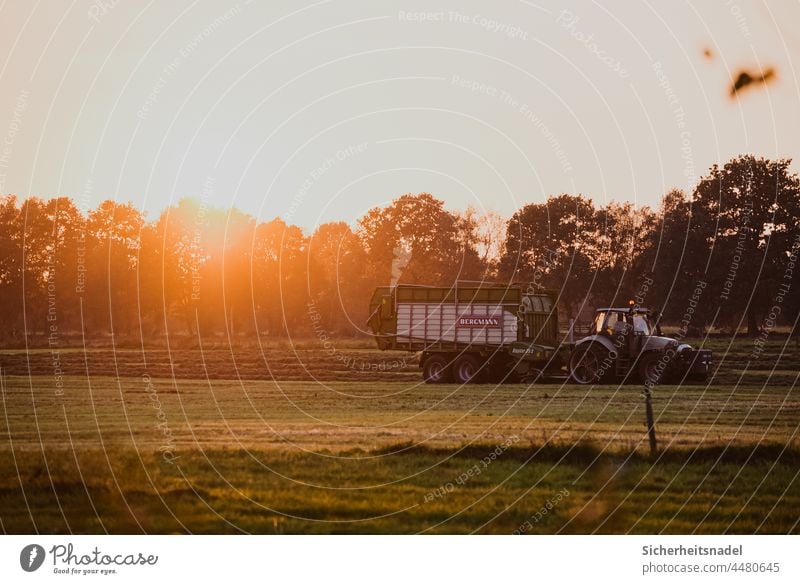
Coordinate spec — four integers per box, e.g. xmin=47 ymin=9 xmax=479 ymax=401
xmin=0 ymin=0 xmax=800 ymax=232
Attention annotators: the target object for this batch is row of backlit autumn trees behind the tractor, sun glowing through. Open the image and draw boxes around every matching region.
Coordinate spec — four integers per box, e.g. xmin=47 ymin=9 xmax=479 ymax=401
xmin=0 ymin=155 xmax=800 ymax=343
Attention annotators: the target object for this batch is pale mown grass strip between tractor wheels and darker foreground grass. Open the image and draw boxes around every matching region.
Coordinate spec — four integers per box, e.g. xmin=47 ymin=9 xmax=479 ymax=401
xmin=0 ymin=377 xmax=800 ymax=452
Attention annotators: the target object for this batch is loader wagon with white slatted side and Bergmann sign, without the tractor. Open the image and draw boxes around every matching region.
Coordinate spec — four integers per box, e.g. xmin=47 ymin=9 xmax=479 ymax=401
xmin=367 ymin=285 xmax=564 ymax=383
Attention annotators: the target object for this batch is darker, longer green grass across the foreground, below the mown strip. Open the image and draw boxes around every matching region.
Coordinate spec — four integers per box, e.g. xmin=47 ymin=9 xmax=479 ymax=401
xmin=0 ymin=445 xmax=800 ymax=534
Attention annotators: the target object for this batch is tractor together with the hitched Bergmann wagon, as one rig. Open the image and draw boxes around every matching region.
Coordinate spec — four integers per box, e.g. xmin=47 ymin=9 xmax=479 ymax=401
xmin=367 ymin=284 xmax=713 ymax=386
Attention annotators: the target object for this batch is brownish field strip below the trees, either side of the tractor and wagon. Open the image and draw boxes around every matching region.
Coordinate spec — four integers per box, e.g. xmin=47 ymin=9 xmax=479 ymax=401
xmin=0 ymin=337 xmax=800 ymax=385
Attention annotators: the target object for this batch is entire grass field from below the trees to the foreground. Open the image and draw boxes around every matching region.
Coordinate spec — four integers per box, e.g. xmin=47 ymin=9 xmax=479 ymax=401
xmin=0 ymin=340 xmax=800 ymax=533
